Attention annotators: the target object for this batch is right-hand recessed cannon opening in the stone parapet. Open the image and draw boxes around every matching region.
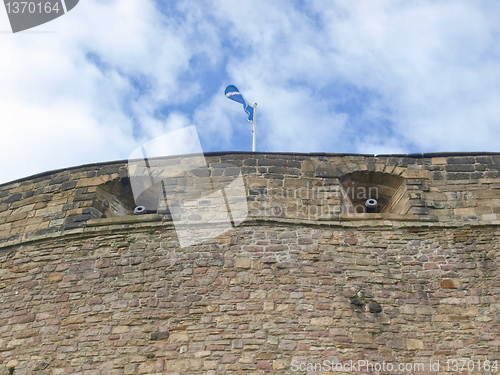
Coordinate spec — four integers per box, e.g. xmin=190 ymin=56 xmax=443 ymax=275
xmin=340 ymin=171 xmax=409 ymax=214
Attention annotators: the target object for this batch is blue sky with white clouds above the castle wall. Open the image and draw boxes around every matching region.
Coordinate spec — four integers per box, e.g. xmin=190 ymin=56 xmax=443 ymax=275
xmin=0 ymin=0 xmax=500 ymax=183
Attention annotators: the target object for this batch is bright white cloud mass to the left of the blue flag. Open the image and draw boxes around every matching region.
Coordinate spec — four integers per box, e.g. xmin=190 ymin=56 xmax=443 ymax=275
xmin=0 ymin=0 xmax=213 ymax=182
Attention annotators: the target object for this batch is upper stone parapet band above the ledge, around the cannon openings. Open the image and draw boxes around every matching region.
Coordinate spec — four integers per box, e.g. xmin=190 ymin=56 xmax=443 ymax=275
xmin=0 ymin=153 xmax=500 ymax=250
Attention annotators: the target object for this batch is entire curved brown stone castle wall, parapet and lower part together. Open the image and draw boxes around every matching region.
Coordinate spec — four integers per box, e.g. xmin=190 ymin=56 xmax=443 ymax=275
xmin=0 ymin=154 xmax=500 ymax=375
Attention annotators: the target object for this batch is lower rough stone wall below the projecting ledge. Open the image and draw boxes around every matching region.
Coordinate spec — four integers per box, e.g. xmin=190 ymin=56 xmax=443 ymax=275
xmin=0 ymin=222 xmax=500 ymax=375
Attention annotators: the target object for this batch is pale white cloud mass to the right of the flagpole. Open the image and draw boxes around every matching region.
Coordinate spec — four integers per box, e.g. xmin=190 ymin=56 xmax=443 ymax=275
xmin=206 ymin=0 xmax=500 ymax=152
